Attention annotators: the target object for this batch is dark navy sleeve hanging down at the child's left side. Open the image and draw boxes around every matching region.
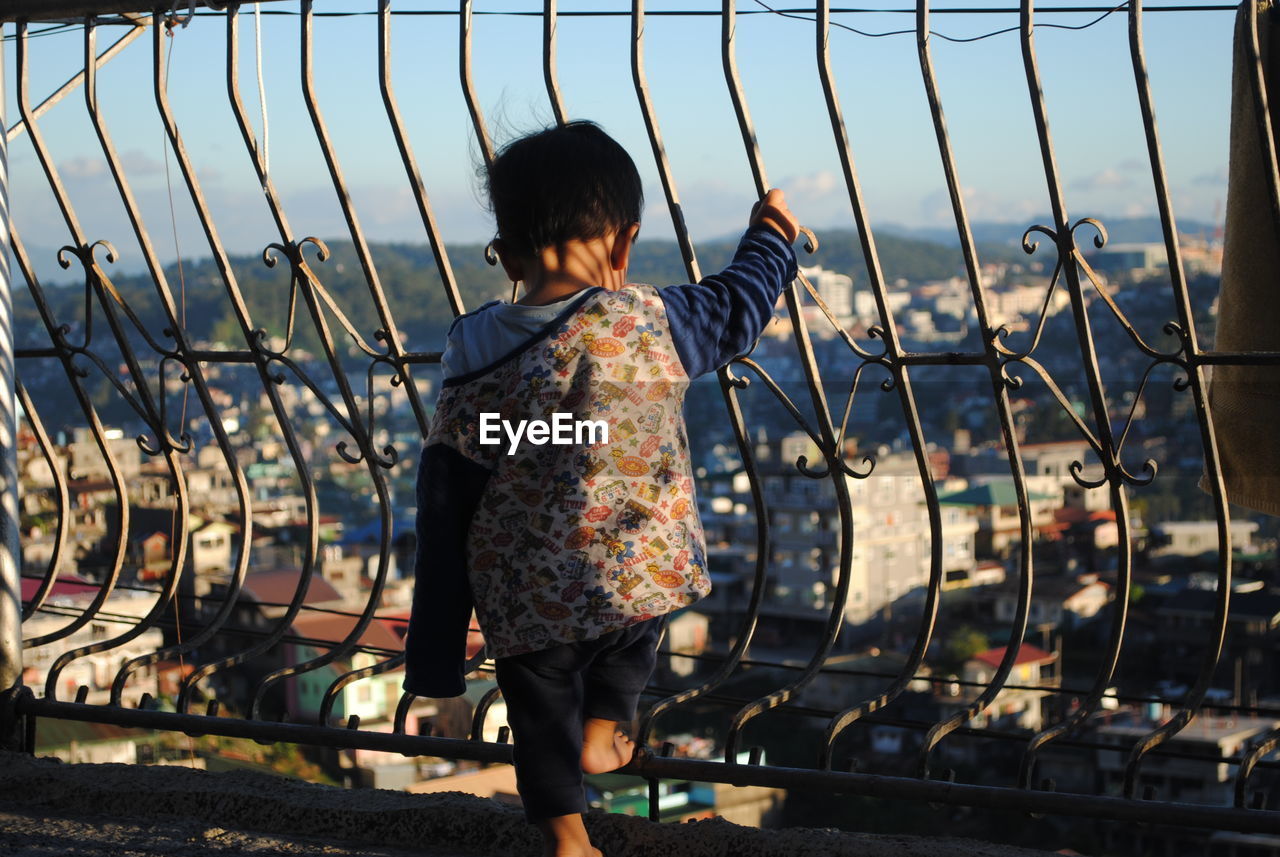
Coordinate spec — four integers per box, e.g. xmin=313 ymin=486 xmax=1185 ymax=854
xmin=403 ymin=444 xmax=489 ymax=698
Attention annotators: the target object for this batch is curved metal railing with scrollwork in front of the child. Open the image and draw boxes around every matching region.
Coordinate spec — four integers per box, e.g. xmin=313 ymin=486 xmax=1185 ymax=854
xmin=0 ymin=0 xmax=1280 ymax=831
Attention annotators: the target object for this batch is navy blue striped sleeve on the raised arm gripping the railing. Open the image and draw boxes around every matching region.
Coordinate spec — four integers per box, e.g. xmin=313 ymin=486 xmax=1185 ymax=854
xmin=658 ymin=225 xmax=796 ymax=380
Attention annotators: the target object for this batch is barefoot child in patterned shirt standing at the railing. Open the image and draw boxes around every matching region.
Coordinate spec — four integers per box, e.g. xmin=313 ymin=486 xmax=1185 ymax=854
xmin=404 ymin=122 xmax=799 ymax=857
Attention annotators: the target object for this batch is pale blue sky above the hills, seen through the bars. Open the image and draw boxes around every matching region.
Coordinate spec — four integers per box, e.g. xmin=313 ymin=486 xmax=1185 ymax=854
xmin=4 ymin=0 xmax=1234 ymax=276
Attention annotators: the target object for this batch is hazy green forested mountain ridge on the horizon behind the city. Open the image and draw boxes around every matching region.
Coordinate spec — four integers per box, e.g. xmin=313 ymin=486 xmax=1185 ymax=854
xmin=14 ymin=220 xmax=1158 ymax=350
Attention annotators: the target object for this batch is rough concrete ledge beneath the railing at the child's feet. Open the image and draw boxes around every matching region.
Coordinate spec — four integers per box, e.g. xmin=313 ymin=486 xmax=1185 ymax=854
xmin=0 ymin=752 xmax=1050 ymax=857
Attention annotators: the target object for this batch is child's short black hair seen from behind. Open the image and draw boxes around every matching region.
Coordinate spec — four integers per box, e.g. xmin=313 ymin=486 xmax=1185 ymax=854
xmin=485 ymin=120 xmax=644 ymax=257
